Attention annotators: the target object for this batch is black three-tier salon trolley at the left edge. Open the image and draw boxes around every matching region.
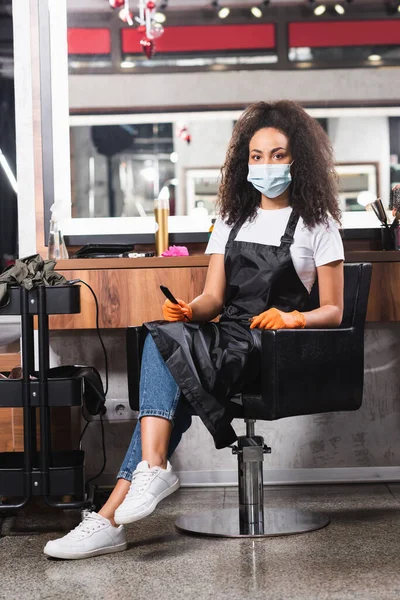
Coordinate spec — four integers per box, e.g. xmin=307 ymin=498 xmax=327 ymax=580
xmin=0 ymin=285 xmax=91 ymax=518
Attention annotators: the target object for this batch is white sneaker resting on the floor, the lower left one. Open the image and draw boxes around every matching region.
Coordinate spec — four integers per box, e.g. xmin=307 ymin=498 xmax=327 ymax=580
xmin=43 ymin=512 xmax=128 ymax=559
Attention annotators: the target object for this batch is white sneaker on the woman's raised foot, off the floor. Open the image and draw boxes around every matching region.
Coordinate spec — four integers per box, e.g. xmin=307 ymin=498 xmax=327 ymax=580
xmin=114 ymin=460 xmax=179 ymax=524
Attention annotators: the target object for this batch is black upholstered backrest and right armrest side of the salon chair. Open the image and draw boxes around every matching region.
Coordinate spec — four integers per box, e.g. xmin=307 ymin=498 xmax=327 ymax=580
xmin=243 ymin=264 xmax=372 ymax=421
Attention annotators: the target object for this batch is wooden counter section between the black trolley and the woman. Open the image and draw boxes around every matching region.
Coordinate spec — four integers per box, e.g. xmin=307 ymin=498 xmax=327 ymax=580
xmin=50 ymin=254 xmax=209 ymax=329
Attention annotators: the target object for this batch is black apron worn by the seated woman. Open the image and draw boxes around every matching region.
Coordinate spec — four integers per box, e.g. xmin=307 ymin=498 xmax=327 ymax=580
xmin=144 ymin=211 xmax=309 ymax=448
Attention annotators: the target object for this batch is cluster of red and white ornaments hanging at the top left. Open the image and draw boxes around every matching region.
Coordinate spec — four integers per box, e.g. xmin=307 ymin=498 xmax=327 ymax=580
xmin=108 ymin=0 xmax=164 ymax=59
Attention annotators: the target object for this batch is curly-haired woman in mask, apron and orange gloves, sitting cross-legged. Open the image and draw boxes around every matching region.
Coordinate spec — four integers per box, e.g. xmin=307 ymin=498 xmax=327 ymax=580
xmin=44 ymin=101 xmax=343 ymax=559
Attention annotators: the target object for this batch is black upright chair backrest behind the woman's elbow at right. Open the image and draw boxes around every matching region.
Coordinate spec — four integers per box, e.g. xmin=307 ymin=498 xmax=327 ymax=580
xmin=311 ymin=263 xmax=372 ymax=328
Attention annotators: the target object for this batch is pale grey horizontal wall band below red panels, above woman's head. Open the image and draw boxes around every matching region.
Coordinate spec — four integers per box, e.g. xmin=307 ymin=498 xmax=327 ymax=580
xmin=69 ymin=67 xmax=400 ymax=111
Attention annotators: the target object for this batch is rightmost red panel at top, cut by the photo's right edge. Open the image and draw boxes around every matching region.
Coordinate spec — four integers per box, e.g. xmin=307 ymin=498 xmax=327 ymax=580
xmin=289 ymin=20 xmax=400 ymax=48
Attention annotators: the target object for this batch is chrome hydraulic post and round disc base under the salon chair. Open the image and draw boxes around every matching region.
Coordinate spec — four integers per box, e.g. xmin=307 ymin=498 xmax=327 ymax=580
xmin=175 ymin=419 xmax=329 ymax=538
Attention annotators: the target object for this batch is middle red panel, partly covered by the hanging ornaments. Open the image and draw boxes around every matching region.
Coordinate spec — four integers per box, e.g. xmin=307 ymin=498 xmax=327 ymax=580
xmin=121 ymin=24 xmax=275 ymax=54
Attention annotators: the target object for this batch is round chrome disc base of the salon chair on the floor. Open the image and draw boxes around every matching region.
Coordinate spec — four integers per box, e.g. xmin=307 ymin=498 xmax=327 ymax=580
xmin=175 ymin=507 xmax=329 ymax=538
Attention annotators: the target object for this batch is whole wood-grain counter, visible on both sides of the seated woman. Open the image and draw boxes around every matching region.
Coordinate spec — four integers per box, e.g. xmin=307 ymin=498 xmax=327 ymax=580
xmin=50 ymin=250 xmax=400 ymax=329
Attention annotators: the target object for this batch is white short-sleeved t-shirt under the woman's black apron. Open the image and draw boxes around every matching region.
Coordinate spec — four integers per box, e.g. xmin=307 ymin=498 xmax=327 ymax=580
xmin=206 ymin=206 xmax=344 ymax=292
